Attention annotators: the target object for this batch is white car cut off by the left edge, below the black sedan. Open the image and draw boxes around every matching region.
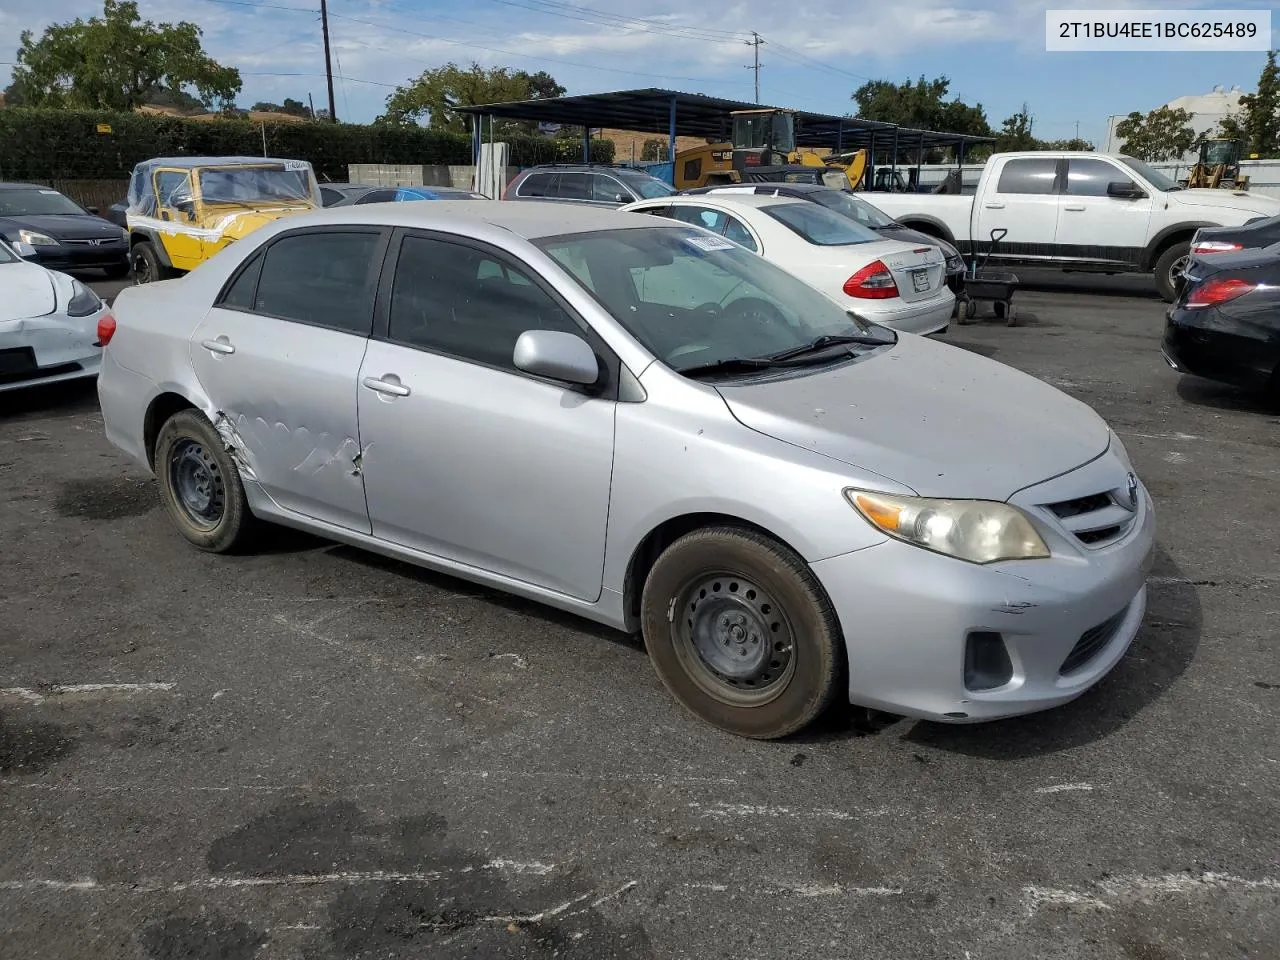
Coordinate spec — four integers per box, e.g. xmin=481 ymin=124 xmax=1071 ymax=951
xmin=0 ymin=241 xmax=110 ymax=392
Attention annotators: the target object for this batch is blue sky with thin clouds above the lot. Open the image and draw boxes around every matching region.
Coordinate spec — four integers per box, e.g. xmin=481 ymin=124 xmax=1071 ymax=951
xmin=0 ymin=0 xmax=1280 ymax=146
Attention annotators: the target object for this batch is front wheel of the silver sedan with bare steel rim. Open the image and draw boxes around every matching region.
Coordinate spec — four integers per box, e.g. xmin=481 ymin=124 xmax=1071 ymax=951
xmin=641 ymin=526 xmax=845 ymax=740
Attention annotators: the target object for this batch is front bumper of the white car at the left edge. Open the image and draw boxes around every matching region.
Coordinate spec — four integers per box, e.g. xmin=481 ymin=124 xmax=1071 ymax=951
xmin=0 ymin=306 xmax=106 ymax=392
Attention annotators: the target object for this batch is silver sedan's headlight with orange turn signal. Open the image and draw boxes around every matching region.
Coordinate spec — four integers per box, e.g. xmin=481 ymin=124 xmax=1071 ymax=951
xmin=845 ymin=489 xmax=1050 ymax=563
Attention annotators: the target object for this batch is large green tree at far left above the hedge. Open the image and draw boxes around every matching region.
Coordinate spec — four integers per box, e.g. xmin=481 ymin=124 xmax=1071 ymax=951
xmin=13 ymin=0 xmax=241 ymax=110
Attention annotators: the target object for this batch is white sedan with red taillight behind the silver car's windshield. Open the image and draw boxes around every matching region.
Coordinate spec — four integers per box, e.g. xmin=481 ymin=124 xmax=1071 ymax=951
xmin=621 ymin=193 xmax=955 ymax=334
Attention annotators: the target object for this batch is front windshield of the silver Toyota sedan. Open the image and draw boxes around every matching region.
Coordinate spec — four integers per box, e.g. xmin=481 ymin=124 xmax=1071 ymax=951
xmin=538 ymin=226 xmax=892 ymax=370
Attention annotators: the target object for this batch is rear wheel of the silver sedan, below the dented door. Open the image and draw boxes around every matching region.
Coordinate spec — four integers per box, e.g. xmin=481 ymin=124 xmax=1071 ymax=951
xmin=155 ymin=410 xmax=261 ymax=553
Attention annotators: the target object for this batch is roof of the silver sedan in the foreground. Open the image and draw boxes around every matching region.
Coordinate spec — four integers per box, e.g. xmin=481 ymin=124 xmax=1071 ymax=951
xmin=262 ymin=200 xmax=677 ymax=239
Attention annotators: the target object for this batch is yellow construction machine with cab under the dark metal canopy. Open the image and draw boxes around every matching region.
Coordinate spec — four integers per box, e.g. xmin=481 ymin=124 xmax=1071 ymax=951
xmin=673 ymin=109 xmax=867 ymax=189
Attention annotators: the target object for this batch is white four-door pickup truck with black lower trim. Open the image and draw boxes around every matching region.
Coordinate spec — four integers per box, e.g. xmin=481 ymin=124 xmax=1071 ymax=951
xmin=870 ymin=151 xmax=1280 ymax=301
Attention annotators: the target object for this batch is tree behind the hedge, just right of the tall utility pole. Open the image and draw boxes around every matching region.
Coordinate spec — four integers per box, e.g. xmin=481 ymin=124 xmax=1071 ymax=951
xmin=378 ymin=63 xmax=564 ymax=136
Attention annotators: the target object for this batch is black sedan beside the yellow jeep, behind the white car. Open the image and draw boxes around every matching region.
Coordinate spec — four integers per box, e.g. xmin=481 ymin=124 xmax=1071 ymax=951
xmin=0 ymin=183 xmax=129 ymax=278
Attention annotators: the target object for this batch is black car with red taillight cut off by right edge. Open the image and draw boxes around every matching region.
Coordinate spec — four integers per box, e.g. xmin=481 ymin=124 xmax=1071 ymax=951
xmin=1161 ymin=243 xmax=1280 ymax=401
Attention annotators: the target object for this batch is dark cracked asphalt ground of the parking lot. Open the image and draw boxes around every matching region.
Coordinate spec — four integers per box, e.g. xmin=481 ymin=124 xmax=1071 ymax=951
xmin=0 ymin=276 xmax=1280 ymax=960
